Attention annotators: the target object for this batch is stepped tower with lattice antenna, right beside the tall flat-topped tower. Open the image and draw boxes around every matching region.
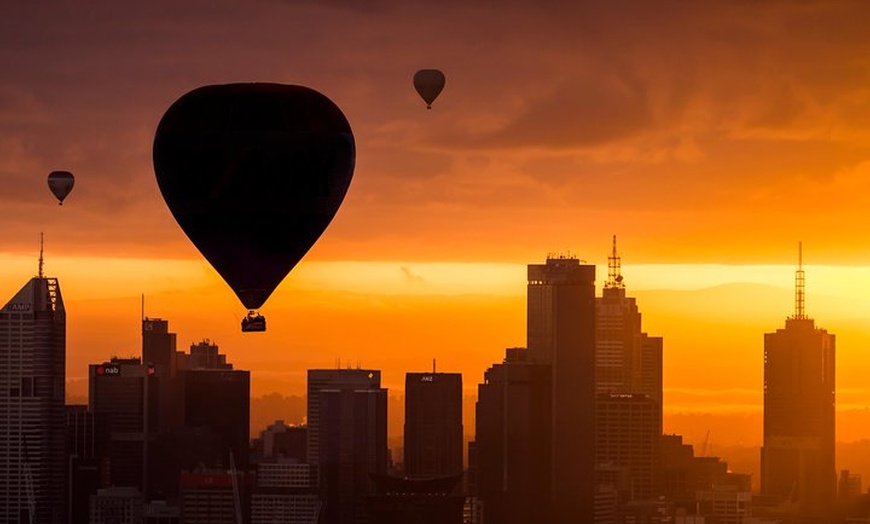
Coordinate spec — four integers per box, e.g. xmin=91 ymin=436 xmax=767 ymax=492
xmin=595 ymin=235 xmax=662 ymax=402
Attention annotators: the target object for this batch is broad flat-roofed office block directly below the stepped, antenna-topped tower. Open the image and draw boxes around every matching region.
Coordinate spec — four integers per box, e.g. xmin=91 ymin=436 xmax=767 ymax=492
xmin=595 ymin=393 xmax=662 ymax=502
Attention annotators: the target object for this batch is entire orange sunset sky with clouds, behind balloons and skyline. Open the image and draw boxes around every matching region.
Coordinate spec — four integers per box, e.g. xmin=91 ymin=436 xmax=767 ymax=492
xmin=0 ymin=0 xmax=870 ymax=448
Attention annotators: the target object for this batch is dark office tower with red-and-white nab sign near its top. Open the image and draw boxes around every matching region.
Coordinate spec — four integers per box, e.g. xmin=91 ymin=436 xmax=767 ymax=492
xmin=88 ymin=357 xmax=158 ymax=493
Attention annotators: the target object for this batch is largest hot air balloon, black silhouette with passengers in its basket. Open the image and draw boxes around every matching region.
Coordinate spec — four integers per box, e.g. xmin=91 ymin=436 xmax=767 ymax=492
xmin=153 ymin=83 xmax=355 ymax=331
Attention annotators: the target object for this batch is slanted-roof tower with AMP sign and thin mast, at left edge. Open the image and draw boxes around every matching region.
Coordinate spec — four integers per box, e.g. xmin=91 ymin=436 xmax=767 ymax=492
xmin=0 ymin=266 xmax=66 ymax=524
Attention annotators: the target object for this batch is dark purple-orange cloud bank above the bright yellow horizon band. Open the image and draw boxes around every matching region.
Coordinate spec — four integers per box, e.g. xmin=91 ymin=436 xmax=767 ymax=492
xmin=0 ymin=0 xmax=870 ymax=260
